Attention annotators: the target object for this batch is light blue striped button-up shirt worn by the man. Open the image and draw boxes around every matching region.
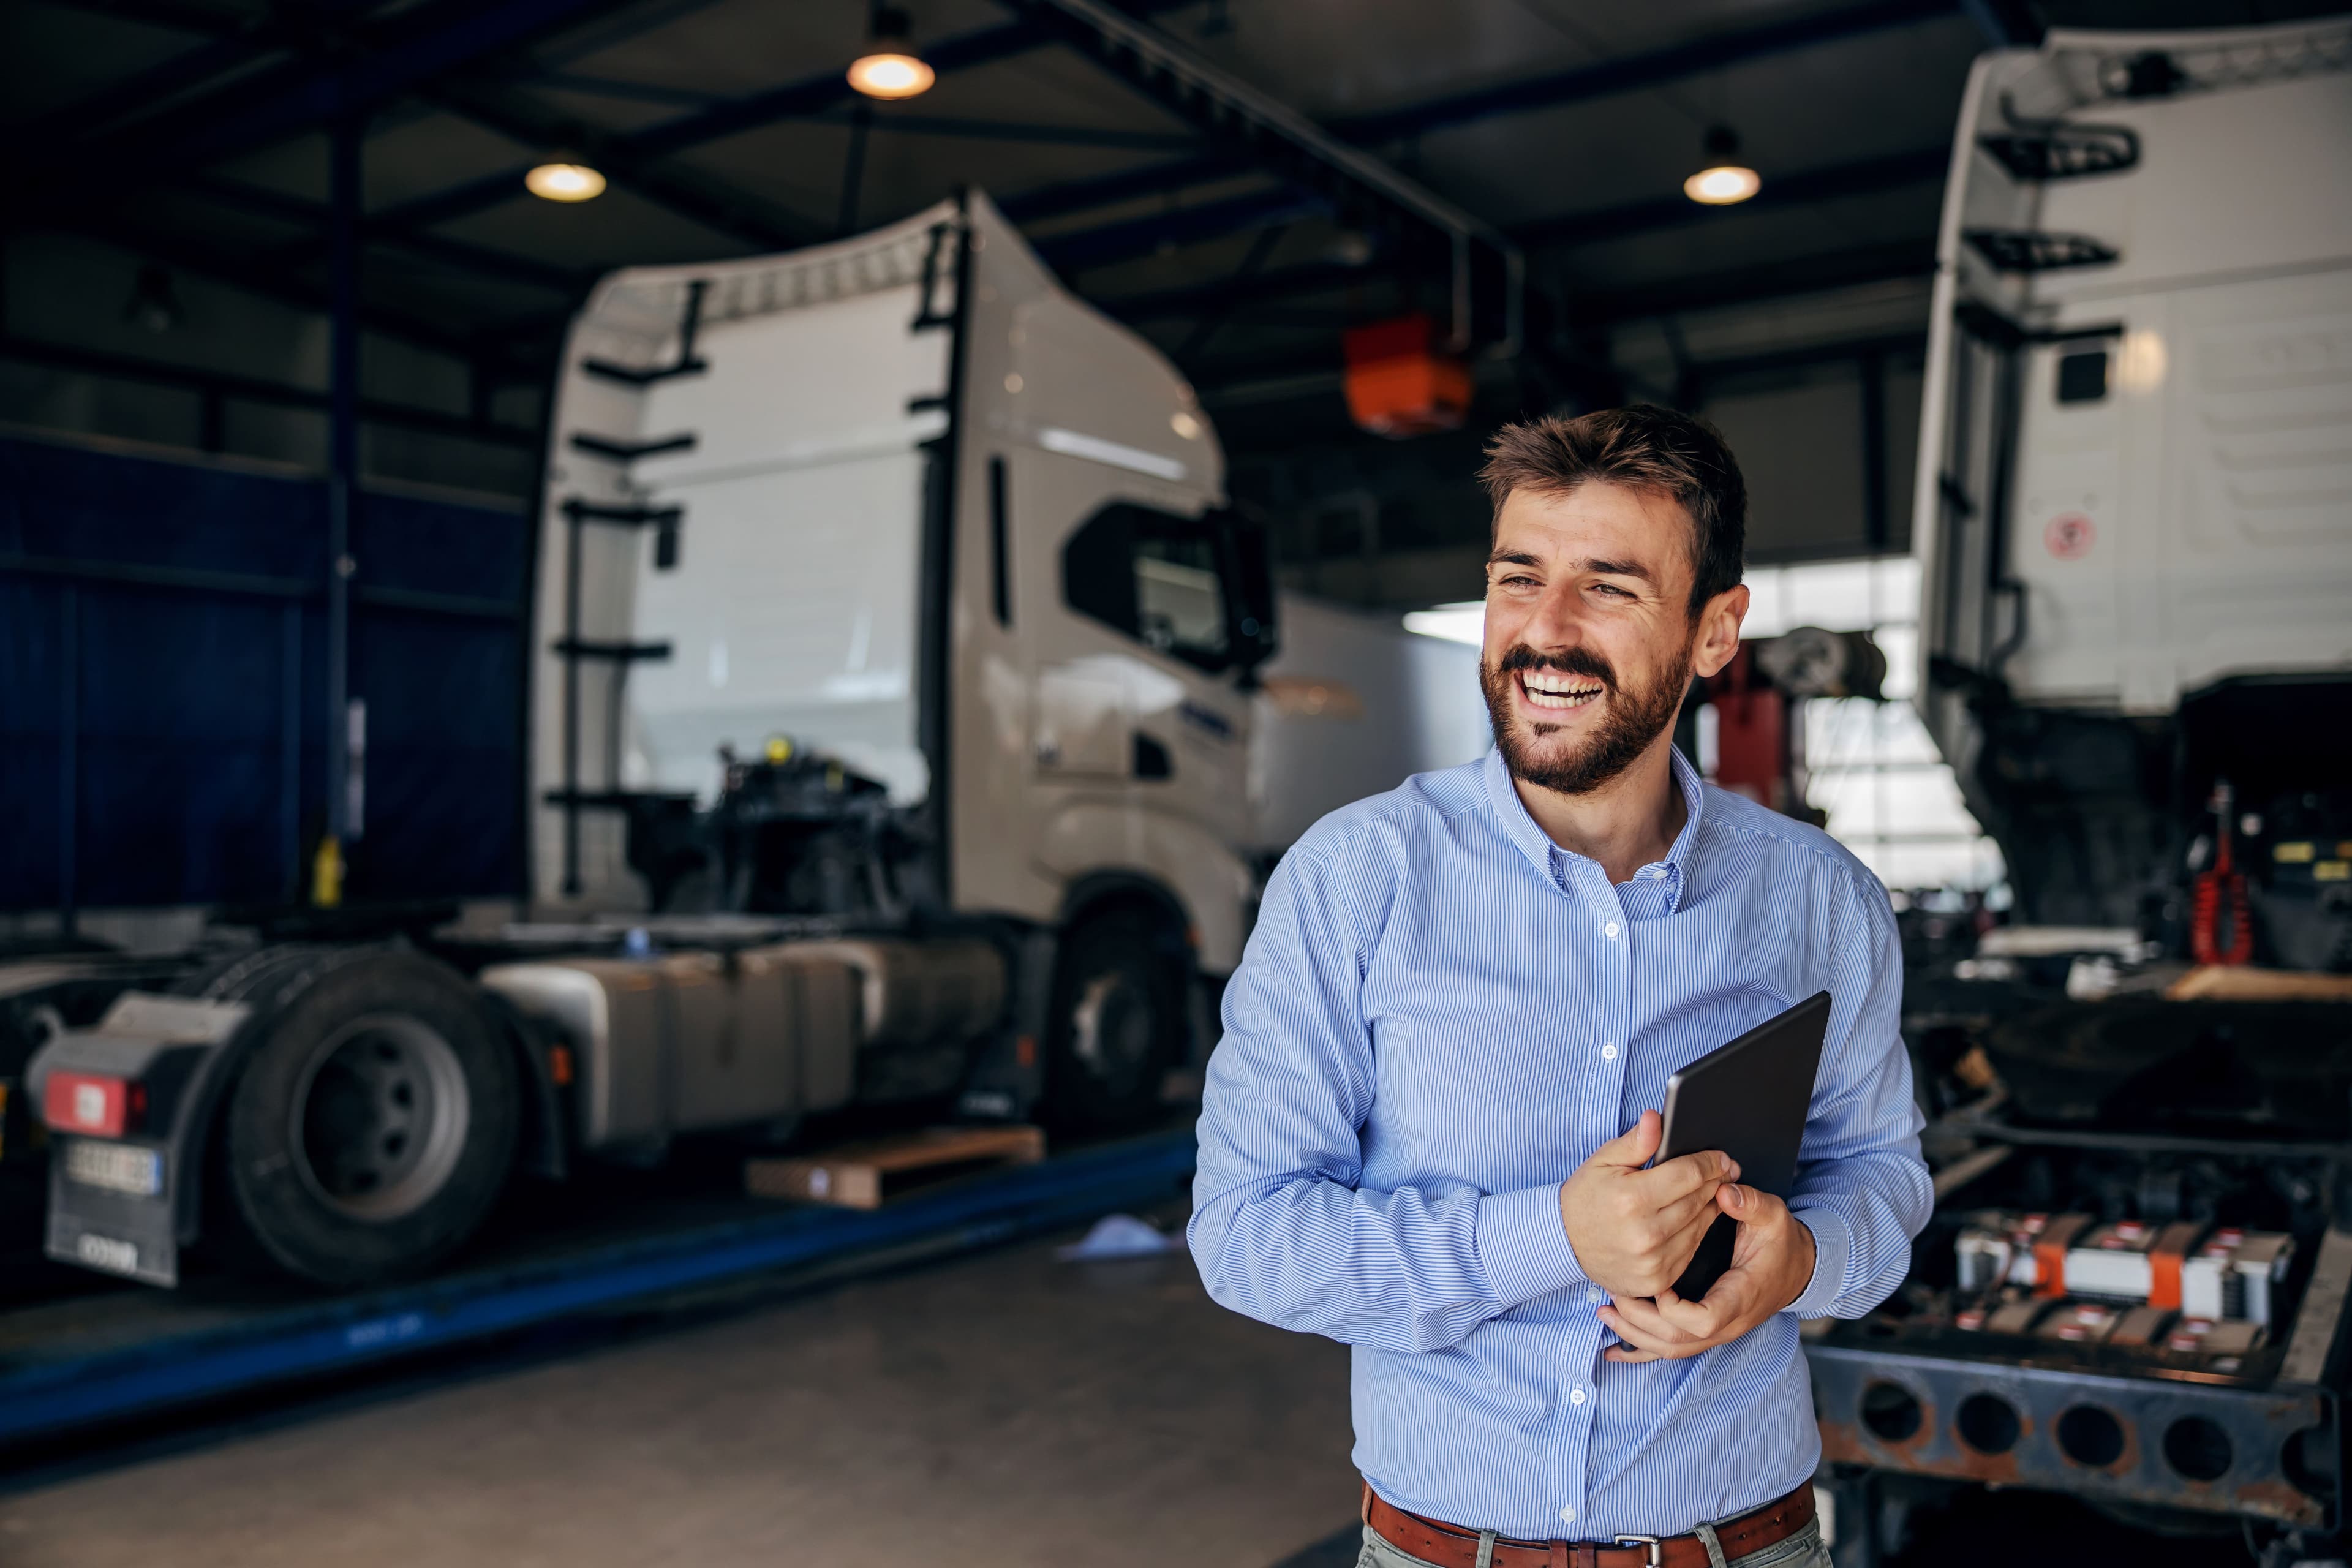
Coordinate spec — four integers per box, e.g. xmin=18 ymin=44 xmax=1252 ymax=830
xmin=1190 ymin=752 xmax=1933 ymax=1540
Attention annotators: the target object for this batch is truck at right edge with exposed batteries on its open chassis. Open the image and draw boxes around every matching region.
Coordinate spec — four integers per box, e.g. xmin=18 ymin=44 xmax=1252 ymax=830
xmin=1806 ymin=17 xmax=2352 ymax=1566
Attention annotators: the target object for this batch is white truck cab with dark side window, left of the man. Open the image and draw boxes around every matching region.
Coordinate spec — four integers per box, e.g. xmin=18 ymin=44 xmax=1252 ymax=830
xmin=534 ymin=195 xmax=1275 ymax=973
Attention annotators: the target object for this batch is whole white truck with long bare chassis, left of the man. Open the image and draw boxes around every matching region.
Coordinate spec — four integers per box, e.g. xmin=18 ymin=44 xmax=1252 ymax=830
xmin=18 ymin=193 xmax=1484 ymax=1291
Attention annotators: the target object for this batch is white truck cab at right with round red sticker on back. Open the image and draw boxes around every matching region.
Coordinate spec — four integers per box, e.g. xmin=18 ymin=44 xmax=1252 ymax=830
xmin=1912 ymin=17 xmax=2352 ymax=930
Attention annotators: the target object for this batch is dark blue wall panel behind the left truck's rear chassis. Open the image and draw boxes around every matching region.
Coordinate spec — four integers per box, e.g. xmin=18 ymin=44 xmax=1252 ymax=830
xmin=0 ymin=440 xmax=532 ymax=910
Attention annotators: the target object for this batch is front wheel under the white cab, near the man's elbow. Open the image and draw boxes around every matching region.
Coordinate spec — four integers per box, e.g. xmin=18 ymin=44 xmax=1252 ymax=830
xmin=1044 ymin=907 xmax=1185 ymax=1133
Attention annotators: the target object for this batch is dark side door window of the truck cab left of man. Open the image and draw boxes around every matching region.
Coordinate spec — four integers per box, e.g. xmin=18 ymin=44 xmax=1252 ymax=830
xmin=1061 ymin=501 xmax=1232 ymax=673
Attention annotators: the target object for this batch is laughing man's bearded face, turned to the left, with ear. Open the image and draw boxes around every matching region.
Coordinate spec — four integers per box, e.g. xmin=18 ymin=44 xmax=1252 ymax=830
xmin=1479 ymin=482 xmax=1747 ymax=794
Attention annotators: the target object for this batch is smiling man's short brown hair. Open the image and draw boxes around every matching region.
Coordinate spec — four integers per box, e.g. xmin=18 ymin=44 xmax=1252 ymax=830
xmin=1479 ymin=402 xmax=1747 ymax=618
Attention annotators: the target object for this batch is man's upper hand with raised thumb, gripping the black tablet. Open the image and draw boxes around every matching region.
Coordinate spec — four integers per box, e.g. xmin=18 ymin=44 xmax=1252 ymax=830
xmin=1559 ymin=1110 xmax=1741 ymax=1300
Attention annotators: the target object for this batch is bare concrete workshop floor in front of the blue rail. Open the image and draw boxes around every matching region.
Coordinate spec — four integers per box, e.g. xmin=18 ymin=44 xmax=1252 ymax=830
xmin=0 ymin=1213 xmax=1355 ymax=1568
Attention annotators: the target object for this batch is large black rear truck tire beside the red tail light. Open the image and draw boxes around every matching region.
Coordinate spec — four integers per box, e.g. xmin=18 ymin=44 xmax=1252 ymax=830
xmin=207 ymin=948 xmax=522 ymax=1291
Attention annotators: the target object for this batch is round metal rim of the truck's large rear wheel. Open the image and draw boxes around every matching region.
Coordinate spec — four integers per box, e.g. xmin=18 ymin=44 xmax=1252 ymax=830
xmin=289 ymin=1013 xmax=470 ymax=1223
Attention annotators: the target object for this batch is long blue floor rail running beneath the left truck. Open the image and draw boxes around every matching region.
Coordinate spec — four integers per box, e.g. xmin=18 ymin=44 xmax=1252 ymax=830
xmin=0 ymin=1128 xmax=1195 ymax=1446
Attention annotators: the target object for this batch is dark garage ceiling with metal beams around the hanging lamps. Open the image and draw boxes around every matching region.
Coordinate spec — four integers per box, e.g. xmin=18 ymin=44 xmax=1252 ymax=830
xmin=0 ymin=0 xmax=2324 ymax=435
